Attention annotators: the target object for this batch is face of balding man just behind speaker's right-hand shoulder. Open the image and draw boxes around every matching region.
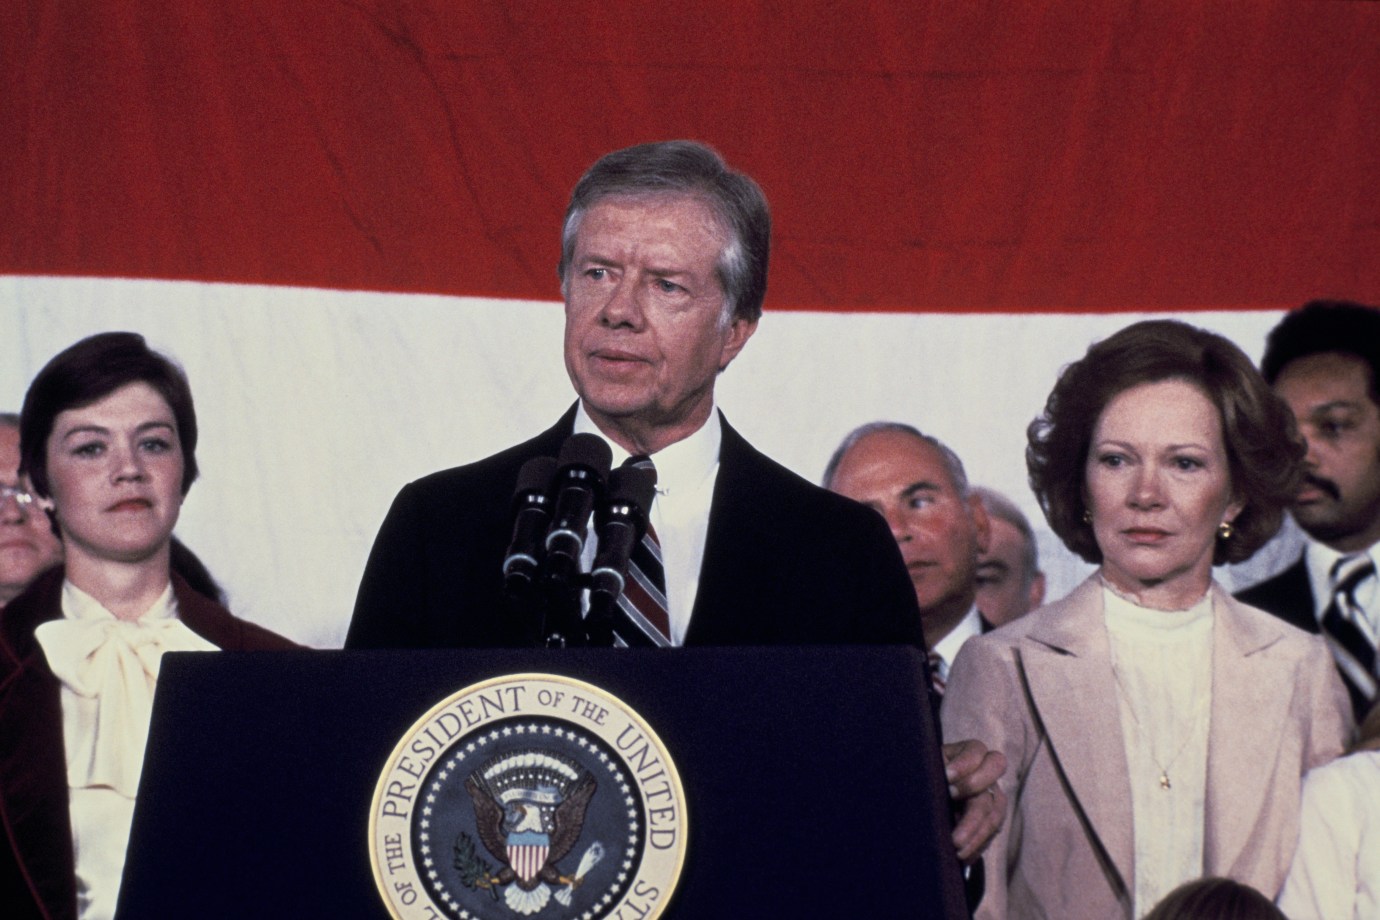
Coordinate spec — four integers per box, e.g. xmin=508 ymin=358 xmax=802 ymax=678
xmin=832 ymin=432 xmax=991 ymax=634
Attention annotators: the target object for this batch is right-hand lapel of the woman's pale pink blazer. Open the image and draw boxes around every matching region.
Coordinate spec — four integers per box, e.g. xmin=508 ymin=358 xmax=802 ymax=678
xmin=1203 ymin=586 xmax=1290 ymax=874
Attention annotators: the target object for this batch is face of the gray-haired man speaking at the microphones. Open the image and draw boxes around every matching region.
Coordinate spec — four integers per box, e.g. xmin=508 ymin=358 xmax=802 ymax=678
xmin=564 ymin=194 xmax=756 ymax=452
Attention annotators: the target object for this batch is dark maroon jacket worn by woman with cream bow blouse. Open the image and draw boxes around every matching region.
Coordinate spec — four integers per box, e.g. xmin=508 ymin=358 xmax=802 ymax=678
xmin=0 ymin=567 xmax=294 ymax=920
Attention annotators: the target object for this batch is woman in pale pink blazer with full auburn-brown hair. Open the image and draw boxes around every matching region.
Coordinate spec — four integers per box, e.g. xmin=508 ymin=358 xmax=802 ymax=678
xmin=944 ymin=321 xmax=1351 ymax=919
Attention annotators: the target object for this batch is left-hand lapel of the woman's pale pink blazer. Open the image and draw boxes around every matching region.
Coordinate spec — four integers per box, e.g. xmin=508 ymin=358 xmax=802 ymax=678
xmin=1017 ymin=578 xmax=1134 ymax=890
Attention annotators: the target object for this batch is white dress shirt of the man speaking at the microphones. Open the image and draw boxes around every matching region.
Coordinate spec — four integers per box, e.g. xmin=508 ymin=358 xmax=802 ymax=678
xmin=574 ymin=401 xmax=723 ymax=646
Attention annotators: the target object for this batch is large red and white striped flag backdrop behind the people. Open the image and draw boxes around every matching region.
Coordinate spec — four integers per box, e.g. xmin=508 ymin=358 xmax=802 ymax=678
xmin=0 ymin=0 xmax=1380 ymax=646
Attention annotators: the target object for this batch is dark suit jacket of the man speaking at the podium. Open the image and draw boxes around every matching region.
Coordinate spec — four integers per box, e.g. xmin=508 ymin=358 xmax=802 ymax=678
xmin=345 ymin=408 xmax=923 ymax=648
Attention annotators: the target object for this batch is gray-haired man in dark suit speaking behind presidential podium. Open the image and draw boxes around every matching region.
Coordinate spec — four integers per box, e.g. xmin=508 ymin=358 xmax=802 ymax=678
xmin=345 ymin=141 xmax=1005 ymax=859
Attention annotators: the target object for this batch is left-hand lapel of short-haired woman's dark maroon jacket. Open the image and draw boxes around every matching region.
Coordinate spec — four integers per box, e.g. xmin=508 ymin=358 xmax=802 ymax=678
xmin=0 ymin=568 xmax=76 ymax=917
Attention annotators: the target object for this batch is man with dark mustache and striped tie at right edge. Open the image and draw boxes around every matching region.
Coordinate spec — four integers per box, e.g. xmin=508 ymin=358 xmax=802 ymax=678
xmin=1238 ymin=301 xmax=1380 ymax=723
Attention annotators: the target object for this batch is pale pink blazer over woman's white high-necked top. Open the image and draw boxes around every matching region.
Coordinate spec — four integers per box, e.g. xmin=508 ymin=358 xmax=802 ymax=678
xmin=943 ymin=575 xmax=1352 ymax=920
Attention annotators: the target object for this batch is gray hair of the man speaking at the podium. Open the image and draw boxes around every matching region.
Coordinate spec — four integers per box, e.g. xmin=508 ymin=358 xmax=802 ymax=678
xmin=558 ymin=141 xmax=771 ymax=324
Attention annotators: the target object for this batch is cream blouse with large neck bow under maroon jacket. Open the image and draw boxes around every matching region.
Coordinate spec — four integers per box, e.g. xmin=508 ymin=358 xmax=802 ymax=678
xmin=35 ymin=582 xmax=215 ymax=920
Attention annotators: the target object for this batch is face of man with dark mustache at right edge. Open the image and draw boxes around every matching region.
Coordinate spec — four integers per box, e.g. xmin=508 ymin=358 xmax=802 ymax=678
xmin=1275 ymin=352 xmax=1380 ymax=552
